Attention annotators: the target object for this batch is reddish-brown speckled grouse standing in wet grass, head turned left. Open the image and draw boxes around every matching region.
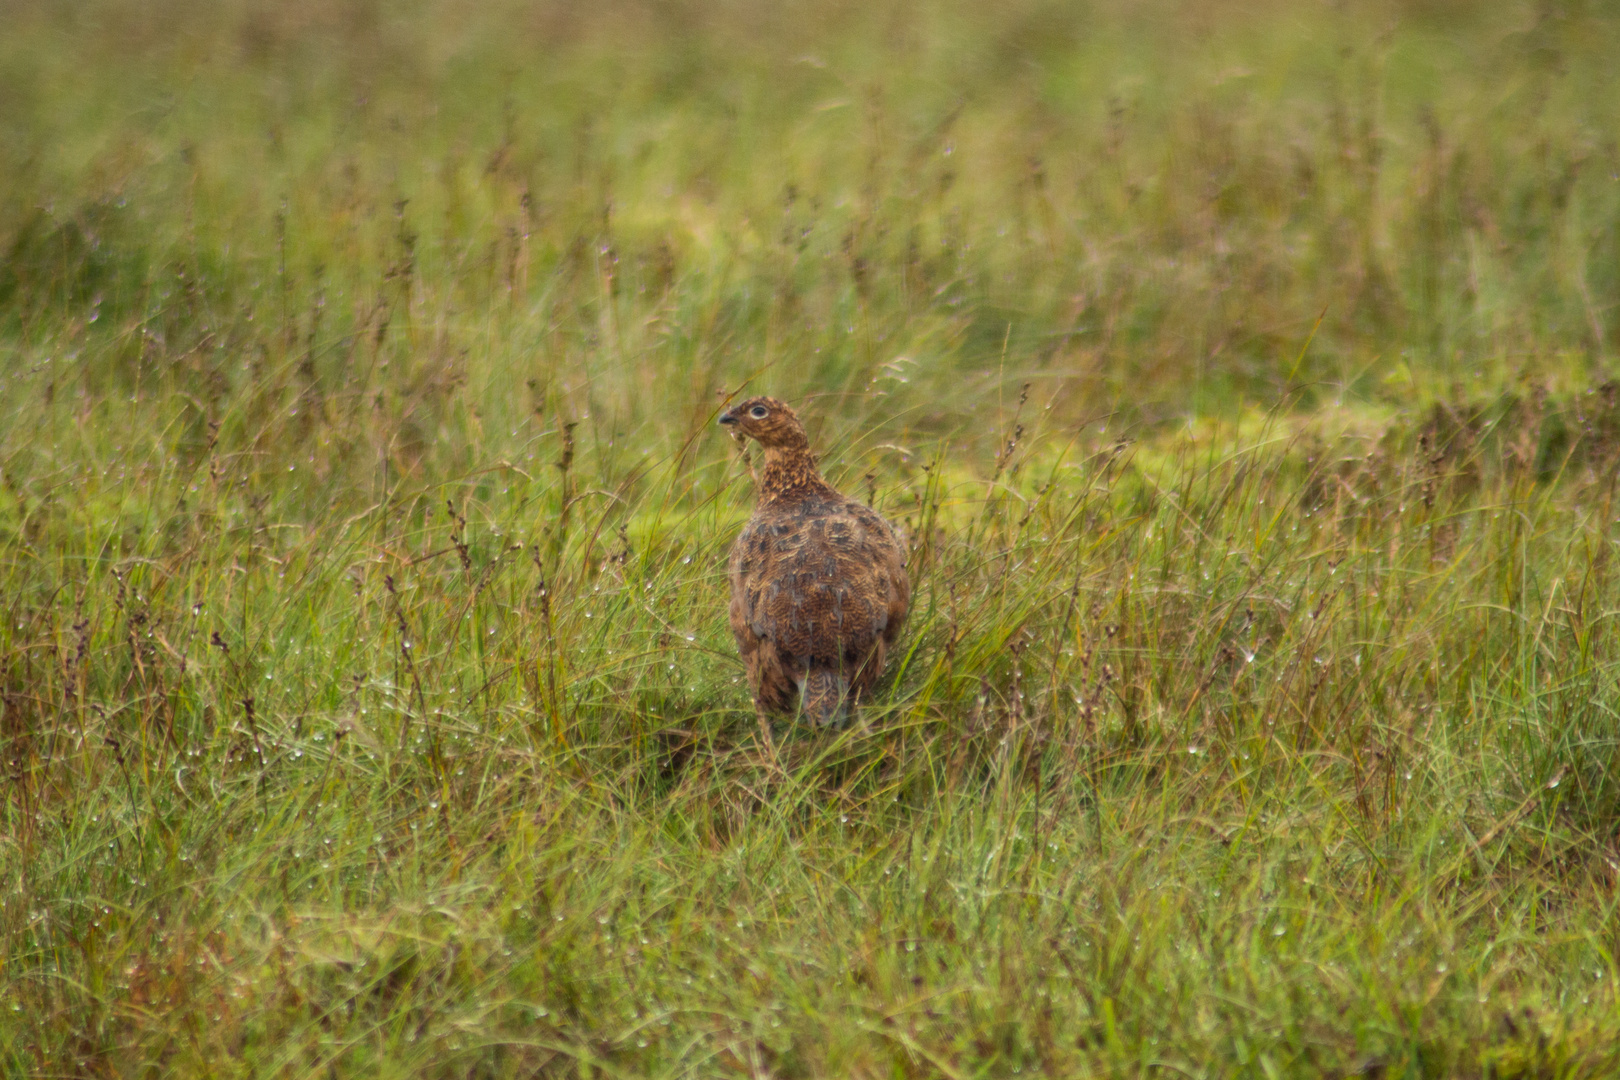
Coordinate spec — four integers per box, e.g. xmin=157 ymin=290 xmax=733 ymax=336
xmin=719 ymin=397 xmax=910 ymax=724
